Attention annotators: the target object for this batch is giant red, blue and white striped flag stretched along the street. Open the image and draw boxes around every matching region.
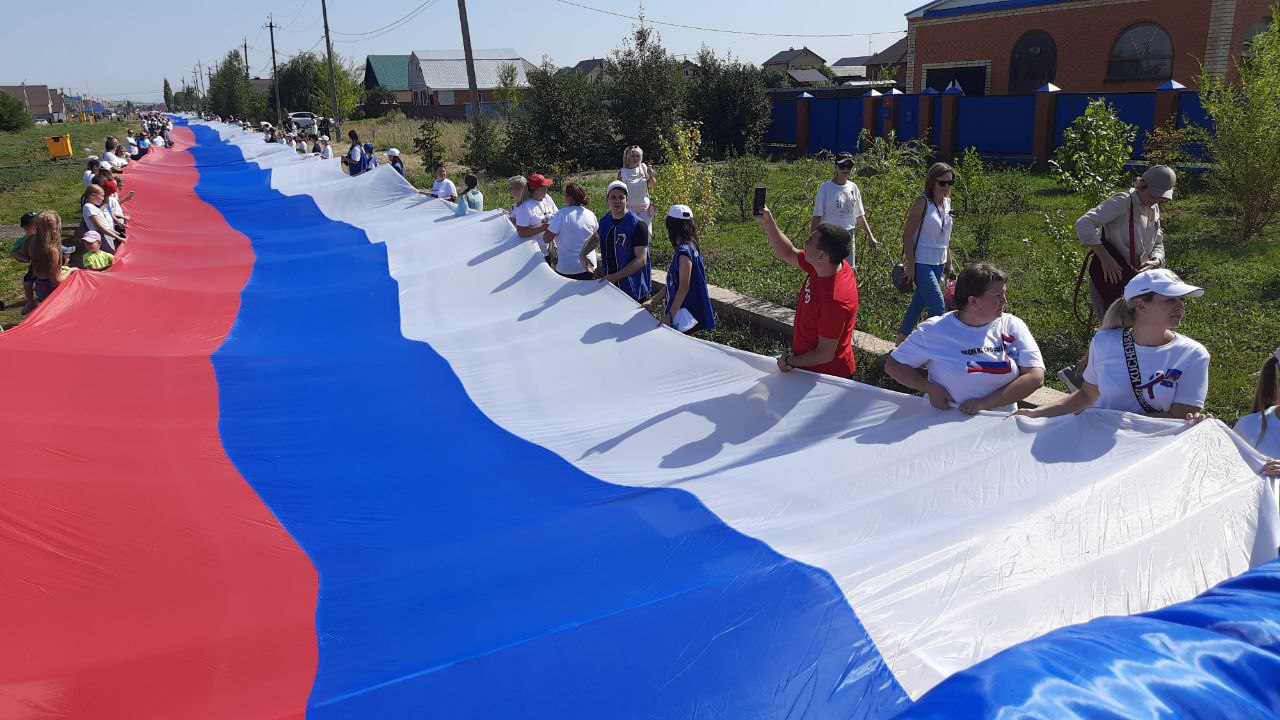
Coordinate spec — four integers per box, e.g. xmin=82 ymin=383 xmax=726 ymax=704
xmin=0 ymin=122 xmax=1280 ymax=719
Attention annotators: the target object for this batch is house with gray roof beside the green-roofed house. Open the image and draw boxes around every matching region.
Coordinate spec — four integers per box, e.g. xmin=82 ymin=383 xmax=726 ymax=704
xmin=408 ymin=47 xmax=535 ymax=119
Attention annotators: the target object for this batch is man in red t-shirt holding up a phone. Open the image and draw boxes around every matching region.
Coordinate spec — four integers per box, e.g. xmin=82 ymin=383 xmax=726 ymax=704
xmin=755 ymin=208 xmax=858 ymax=378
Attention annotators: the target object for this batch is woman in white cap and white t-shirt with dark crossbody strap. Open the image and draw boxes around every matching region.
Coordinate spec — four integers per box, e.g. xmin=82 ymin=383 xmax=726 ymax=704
xmin=1016 ymin=268 xmax=1210 ymax=423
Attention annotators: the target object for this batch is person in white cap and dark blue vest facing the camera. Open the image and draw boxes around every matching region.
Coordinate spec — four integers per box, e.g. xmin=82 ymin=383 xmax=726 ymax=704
xmin=580 ymin=181 xmax=653 ymax=302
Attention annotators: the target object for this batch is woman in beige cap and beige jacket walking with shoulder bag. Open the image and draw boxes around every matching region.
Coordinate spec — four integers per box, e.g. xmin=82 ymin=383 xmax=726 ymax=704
xmin=1059 ymin=165 xmax=1178 ymax=389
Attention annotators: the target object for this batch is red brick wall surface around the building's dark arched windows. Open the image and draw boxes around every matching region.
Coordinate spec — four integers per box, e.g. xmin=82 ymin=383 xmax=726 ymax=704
xmin=909 ymin=0 xmax=1274 ymax=95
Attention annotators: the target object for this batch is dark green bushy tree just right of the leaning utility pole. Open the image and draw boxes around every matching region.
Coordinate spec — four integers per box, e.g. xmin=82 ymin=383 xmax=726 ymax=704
xmin=493 ymin=63 xmax=611 ymax=174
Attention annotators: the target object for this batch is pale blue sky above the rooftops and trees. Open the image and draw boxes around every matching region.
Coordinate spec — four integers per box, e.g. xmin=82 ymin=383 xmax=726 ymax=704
xmin=0 ymin=0 xmax=923 ymax=102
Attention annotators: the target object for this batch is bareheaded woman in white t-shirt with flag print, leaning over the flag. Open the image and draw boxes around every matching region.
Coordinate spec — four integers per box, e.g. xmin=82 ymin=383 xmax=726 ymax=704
xmin=884 ymin=263 xmax=1044 ymax=415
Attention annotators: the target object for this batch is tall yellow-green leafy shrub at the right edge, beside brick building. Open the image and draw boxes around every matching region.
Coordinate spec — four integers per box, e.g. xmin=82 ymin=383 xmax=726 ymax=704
xmin=1198 ymin=8 xmax=1280 ymax=241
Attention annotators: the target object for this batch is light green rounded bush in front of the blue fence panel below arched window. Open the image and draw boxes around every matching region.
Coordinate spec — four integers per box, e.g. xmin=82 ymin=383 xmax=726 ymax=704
xmin=1050 ymin=97 xmax=1138 ymax=202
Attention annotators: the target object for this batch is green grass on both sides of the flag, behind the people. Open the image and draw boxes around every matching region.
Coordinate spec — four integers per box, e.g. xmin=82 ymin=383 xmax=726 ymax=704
xmin=0 ymin=119 xmax=1280 ymax=421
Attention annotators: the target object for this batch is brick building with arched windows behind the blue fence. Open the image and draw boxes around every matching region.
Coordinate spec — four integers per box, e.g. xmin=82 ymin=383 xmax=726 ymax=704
xmin=906 ymin=0 xmax=1275 ymax=95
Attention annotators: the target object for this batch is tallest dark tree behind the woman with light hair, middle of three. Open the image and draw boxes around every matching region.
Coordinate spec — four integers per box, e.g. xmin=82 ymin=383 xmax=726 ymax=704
xmin=601 ymin=20 xmax=689 ymax=161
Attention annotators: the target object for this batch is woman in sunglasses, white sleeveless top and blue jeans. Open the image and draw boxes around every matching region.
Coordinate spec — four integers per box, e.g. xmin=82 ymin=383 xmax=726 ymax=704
xmin=897 ymin=163 xmax=956 ymax=345
